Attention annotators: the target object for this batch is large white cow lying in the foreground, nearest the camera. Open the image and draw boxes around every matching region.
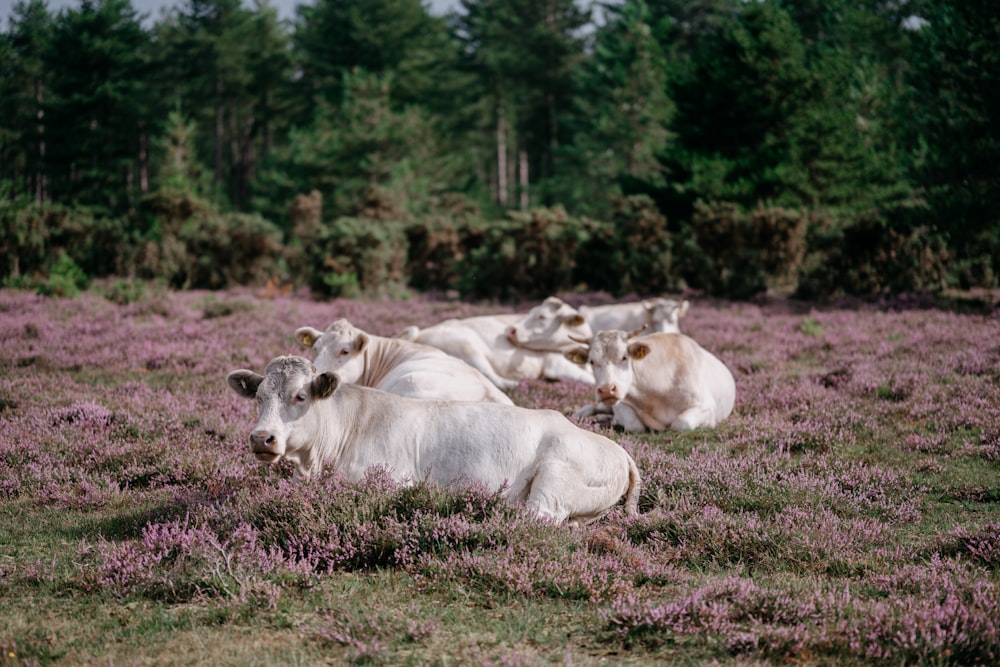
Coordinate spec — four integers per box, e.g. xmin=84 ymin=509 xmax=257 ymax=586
xmin=227 ymin=356 xmax=640 ymax=525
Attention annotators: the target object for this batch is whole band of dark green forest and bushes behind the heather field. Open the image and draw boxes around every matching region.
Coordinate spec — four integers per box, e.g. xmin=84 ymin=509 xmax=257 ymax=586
xmin=0 ymin=0 xmax=1000 ymax=299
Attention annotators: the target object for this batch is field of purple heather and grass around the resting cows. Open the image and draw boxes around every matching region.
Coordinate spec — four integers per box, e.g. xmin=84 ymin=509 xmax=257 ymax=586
xmin=0 ymin=286 xmax=1000 ymax=665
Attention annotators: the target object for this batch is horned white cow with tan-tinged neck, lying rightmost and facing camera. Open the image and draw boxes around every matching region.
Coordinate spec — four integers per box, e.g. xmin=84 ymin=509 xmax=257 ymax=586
xmin=566 ymin=330 xmax=736 ymax=432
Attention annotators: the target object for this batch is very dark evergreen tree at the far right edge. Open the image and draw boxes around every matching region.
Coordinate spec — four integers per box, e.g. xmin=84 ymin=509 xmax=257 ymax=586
xmin=910 ymin=0 xmax=1000 ymax=286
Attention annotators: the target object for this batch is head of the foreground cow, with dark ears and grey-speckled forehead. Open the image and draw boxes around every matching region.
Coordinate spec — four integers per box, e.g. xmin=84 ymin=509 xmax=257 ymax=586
xmin=226 ymin=356 xmax=340 ymax=463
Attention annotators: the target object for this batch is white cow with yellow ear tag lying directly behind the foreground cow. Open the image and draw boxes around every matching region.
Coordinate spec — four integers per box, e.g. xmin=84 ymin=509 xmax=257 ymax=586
xmin=295 ymin=319 xmax=513 ymax=405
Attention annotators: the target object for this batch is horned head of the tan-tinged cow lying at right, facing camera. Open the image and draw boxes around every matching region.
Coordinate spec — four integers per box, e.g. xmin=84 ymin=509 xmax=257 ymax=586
xmin=564 ymin=327 xmax=650 ymax=406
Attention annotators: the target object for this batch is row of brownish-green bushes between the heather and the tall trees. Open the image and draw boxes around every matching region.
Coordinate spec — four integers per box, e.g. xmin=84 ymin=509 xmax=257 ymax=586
xmin=0 ymin=191 xmax=956 ymax=300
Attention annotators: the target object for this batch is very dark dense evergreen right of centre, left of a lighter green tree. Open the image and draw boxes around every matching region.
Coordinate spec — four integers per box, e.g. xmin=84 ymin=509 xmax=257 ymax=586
xmin=673 ymin=3 xmax=815 ymax=206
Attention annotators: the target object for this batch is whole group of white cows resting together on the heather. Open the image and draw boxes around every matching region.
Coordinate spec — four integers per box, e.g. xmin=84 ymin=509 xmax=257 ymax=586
xmin=227 ymin=297 xmax=736 ymax=525
